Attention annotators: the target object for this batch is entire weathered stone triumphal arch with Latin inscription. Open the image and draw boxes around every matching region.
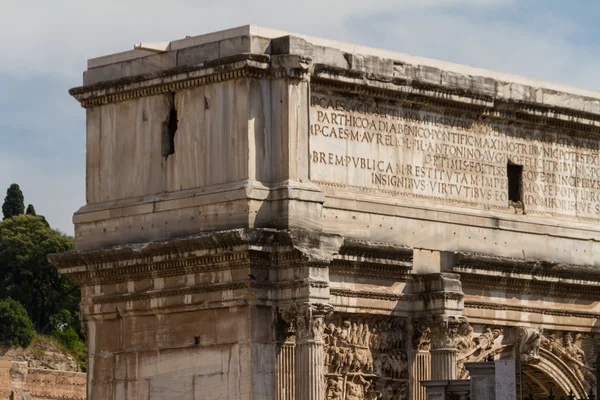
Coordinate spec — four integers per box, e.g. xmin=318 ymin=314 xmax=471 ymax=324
xmin=51 ymin=26 xmax=600 ymax=400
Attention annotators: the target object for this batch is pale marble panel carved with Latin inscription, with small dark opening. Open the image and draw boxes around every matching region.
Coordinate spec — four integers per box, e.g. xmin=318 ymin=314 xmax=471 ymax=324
xmin=310 ymin=91 xmax=600 ymax=220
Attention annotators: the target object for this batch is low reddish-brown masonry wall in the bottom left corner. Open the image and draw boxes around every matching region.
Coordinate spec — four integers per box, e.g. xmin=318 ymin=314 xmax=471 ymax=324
xmin=0 ymin=361 xmax=87 ymax=400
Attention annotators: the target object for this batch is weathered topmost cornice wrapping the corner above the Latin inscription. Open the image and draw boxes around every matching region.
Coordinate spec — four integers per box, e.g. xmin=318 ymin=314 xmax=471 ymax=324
xmin=70 ymin=37 xmax=600 ymax=134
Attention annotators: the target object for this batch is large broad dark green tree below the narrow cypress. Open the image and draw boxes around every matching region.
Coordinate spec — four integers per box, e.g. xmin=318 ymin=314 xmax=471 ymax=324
xmin=0 ymin=215 xmax=80 ymax=334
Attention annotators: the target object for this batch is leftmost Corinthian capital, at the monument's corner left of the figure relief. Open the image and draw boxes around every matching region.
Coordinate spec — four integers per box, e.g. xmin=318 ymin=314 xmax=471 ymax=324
xmin=282 ymin=303 xmax=333 ymax=343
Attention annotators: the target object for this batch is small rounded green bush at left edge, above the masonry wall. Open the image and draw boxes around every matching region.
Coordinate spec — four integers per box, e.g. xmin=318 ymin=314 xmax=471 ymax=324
xmin=0 ymin=297 xmax=35 ymax=347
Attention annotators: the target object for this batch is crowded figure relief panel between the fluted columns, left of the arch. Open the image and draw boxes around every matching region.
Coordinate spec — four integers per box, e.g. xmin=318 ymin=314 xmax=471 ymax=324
xmin=323 ymin=316 xmax=408 ymax=400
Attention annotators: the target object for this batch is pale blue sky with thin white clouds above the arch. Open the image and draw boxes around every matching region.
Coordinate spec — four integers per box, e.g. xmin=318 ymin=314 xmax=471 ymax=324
xmin=0 ymin=0 xmax=600 ymax=235
